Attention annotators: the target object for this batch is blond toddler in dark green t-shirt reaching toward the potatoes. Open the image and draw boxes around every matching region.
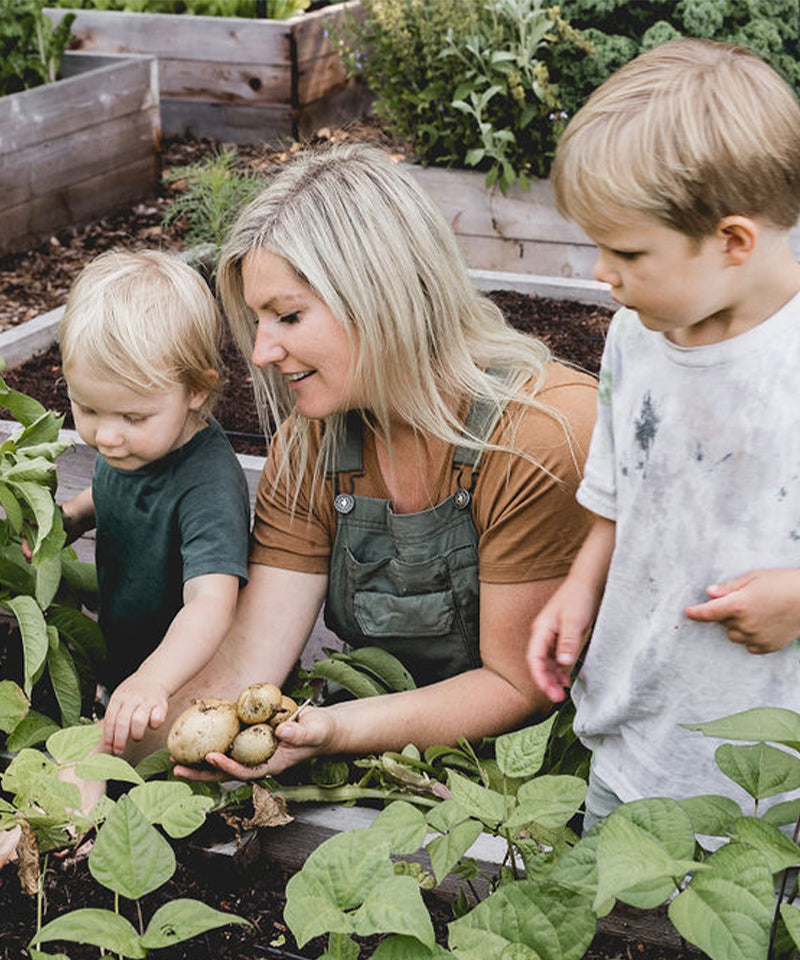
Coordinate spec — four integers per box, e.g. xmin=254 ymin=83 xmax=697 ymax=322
xmin=59 ymin=251 xmax=250 ymax=754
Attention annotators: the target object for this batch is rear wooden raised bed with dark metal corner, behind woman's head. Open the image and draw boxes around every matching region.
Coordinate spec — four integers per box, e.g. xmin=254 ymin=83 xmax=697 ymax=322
xmin=46 ymin=0 xmax=369 ymax=143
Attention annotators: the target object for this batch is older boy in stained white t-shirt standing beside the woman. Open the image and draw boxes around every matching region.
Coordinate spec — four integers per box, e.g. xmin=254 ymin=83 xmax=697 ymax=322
xmin=528 ymin=40 xmax=800 ymax=829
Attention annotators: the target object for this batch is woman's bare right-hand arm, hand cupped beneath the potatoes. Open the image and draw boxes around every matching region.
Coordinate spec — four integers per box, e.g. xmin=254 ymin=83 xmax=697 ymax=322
xmin=197 ymin=578 xmax=561 ymax=779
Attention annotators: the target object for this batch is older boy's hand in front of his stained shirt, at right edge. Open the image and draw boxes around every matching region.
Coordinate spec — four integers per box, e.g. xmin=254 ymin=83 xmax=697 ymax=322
xmin=684 ymin=569 xmax=800 ymax=654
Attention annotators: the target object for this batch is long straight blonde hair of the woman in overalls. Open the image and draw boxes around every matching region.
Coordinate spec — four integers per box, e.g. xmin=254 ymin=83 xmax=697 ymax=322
xmin=217 ymin=145 xmax=549 ymax=496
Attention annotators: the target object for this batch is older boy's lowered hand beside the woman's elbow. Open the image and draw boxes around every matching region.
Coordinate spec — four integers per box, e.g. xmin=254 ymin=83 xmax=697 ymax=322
xmin=527 ymin=578 xmax=596 ymax=703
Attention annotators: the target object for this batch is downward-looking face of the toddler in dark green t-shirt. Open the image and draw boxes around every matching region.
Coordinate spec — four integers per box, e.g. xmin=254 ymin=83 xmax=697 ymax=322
xmin=67 ymin=364 xmax=206 ymax=471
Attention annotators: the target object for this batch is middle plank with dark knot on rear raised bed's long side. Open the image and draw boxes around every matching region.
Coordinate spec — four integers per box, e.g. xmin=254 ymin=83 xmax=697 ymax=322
xmin=158 ymin=57 xmax=292 ymax=106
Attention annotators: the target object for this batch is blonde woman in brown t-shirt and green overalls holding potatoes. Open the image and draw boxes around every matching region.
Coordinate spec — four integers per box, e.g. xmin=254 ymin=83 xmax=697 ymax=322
xmin=156 ymin=146 xmax=595 ymax=779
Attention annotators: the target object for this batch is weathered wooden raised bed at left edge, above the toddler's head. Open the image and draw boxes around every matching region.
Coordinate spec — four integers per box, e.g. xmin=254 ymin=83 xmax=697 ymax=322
xmin=0 ymin=53 xmax=161 ymax=255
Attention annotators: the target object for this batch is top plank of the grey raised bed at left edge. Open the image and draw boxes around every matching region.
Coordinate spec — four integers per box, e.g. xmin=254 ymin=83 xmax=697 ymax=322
xmin=0 ymin=53 xmax=158 ymax=155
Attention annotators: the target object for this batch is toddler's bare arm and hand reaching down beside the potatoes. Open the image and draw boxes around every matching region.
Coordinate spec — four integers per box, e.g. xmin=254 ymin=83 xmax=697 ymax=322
xmin=103 ymin=573 xmax=239 ymax=754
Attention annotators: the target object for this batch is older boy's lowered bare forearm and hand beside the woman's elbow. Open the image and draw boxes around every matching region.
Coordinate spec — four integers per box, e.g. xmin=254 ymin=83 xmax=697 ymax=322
xmin=527 ymin=517 xmax=616 ymax=702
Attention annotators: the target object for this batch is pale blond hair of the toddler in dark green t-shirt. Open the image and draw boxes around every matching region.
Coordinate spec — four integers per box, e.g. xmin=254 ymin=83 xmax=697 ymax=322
xmin=58 ymin=250 xmax=222 ymax=416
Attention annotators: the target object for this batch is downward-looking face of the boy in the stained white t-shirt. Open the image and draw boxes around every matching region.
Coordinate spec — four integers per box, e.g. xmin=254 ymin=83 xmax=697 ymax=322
xmin=590 ymin=212 xmax=735 ymax=346
